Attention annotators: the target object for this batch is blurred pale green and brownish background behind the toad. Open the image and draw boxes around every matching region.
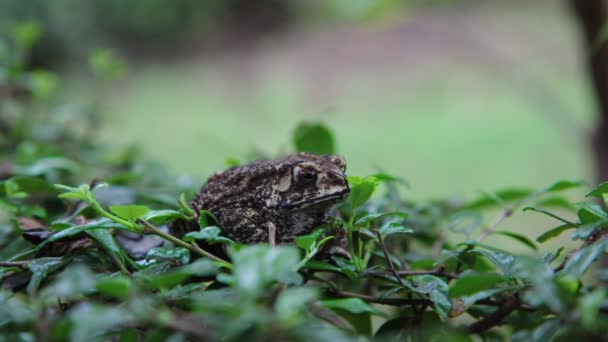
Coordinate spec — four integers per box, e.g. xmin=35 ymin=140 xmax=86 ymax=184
xmin=0 ymin=0 xmax=595 ymax=199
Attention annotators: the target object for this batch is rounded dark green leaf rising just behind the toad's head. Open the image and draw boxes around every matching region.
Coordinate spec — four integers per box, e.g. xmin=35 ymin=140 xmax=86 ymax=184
xmin=293 ymin=122 xmax=336 ymax=154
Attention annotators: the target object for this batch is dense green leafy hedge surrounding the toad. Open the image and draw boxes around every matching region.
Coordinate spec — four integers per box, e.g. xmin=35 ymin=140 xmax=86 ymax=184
xmin=0 ymin=25 xmax=608 ymax=341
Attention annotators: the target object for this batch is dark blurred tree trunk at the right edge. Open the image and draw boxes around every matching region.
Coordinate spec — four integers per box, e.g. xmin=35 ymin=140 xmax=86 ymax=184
xmin=568 ymin=0 xmax=608 ymax=182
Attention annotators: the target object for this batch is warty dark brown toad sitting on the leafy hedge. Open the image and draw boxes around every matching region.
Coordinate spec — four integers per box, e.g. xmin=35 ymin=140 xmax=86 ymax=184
xmin=180 ymin=153 xmax=350 ymax=244
